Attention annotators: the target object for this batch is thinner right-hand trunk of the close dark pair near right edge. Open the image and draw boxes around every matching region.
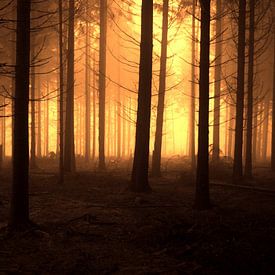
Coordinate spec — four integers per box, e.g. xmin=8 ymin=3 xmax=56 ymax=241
xmin=244 ymin=0 xmax=255 ymax=177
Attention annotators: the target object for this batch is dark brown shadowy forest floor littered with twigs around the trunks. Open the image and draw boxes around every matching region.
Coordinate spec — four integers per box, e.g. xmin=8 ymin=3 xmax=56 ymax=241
xmin=0 ymin=158 xmax=275 ymax=274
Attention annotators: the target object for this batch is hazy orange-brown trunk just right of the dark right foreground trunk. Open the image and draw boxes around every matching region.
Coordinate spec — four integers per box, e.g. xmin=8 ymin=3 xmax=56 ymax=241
xmin=212 ymin=0 xmax=222 ymax=161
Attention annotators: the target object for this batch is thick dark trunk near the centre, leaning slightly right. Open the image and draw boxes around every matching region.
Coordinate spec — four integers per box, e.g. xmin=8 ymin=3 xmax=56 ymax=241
xmin=131 ymin=0 xmax=153 ymax=192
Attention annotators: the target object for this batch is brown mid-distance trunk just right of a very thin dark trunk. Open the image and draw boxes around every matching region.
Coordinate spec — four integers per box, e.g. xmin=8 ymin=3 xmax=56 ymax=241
xmin=64 ymin=0 xmax=75 ymax=172
